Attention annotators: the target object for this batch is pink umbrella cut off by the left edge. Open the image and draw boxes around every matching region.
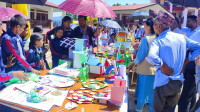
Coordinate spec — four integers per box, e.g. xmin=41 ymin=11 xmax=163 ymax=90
xmin=0 ymin=8 xmax=29 ymax=21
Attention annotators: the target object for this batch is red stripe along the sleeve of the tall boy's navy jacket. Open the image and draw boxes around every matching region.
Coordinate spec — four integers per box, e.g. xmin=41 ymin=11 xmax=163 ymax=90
xmin=6 ymin=40 xmax=30 ymax=68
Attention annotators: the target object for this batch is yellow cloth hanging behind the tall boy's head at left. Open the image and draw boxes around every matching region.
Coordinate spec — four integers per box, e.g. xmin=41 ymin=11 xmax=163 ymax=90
xmin=12 ymin=4 xmax=31 ymax=39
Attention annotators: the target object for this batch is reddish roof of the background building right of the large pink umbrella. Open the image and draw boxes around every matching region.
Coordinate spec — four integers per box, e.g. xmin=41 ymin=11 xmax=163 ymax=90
xmin=112 ymin=3 xmax=156 ymax=11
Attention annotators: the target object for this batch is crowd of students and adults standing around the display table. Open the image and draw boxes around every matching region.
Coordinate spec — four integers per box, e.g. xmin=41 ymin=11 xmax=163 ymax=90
xmin=0 ymin=11 xmax=200 ymax=112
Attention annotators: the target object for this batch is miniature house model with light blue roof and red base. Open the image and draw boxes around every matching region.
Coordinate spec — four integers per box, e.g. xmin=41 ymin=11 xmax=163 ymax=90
xmin=87 ymin=57 xmax=106 ymax=76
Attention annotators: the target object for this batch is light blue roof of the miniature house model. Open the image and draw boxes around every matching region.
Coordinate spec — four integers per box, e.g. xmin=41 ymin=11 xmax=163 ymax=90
xmin=87 ymin=56 xmax=106 ymax=66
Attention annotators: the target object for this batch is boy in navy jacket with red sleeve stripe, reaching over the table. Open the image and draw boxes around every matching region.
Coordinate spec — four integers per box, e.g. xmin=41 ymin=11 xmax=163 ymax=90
xmin=1 ymin=15 xmax=40 ymax=74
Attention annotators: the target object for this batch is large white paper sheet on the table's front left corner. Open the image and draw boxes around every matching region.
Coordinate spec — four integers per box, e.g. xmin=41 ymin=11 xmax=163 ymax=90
xmin=0 ymin=84 xmax=68 ymax=111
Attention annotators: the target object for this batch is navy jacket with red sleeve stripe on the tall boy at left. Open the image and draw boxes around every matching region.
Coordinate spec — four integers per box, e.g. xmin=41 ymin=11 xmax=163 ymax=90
xmin=1 ymin=29 xmax=32 ymax=72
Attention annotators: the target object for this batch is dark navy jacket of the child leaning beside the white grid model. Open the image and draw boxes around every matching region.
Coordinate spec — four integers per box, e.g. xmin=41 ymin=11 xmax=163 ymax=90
xmin=48 ymin=35 xmax=63 ymax=68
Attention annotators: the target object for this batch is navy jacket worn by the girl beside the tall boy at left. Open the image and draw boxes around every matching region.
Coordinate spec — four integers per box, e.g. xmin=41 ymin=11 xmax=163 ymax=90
xmin=26 ymin=46 xmax=43 ymax=70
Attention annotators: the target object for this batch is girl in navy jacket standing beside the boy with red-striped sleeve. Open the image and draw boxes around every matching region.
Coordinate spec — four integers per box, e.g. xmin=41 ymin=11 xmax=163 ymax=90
xmin=26 ymin=33 xmax=46 ymax=70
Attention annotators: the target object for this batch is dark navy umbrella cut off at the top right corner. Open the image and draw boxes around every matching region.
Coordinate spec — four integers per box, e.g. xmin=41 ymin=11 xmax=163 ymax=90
xmin=169 ymin=0 xmax=200 ymax=8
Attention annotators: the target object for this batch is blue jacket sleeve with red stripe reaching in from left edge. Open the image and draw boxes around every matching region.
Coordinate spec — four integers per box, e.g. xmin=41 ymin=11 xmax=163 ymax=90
xmin=0 ymin=47 xmax=14 ymax=89
